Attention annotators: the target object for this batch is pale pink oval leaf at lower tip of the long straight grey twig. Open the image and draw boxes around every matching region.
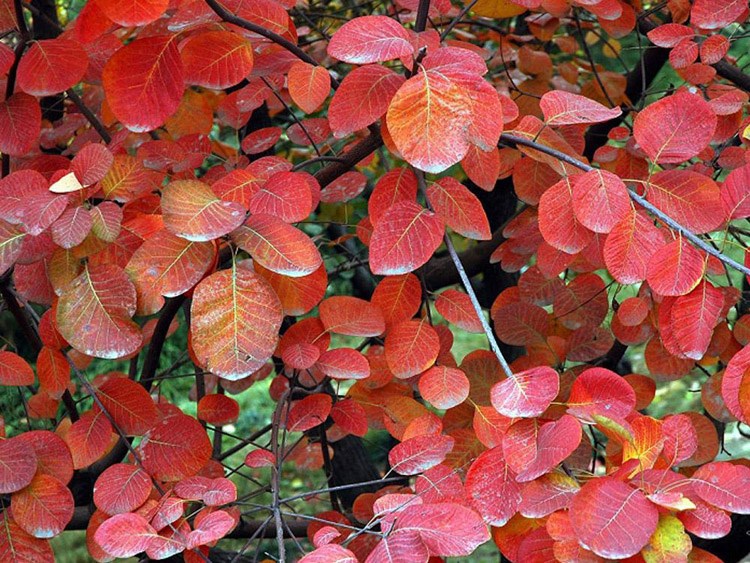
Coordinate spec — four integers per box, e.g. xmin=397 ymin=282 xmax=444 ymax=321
xmin=491 ymin=366 xmax=560 ymax=418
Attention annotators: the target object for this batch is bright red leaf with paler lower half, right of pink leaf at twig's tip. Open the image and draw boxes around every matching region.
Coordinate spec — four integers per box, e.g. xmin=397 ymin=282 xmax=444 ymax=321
xmin=568 ymin=368 xmax=636 ymax=422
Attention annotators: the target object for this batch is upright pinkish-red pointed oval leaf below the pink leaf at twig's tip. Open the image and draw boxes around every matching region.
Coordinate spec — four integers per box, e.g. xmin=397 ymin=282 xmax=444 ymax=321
xmin=466 ymin=446 xmax=521 ymax=526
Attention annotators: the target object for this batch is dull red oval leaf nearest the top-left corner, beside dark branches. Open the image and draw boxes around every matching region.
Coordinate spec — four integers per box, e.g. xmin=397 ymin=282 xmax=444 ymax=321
xmin=17 ymin=37 xmax=89 ymax=96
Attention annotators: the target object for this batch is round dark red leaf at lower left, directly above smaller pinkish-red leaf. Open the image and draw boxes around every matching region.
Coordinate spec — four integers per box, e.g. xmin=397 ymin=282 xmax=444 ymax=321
xmin=139 ymin=414 xmax=211 ymax=481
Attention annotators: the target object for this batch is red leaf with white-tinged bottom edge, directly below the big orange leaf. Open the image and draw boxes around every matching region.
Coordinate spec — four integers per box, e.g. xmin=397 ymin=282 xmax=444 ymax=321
xmin=370 ymin=201 xmax=444 ymax=276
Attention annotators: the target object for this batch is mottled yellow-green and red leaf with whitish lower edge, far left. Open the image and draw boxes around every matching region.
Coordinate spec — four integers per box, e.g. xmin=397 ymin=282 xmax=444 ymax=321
xmin=57 ymin=265 xmax=143 ymax=359
